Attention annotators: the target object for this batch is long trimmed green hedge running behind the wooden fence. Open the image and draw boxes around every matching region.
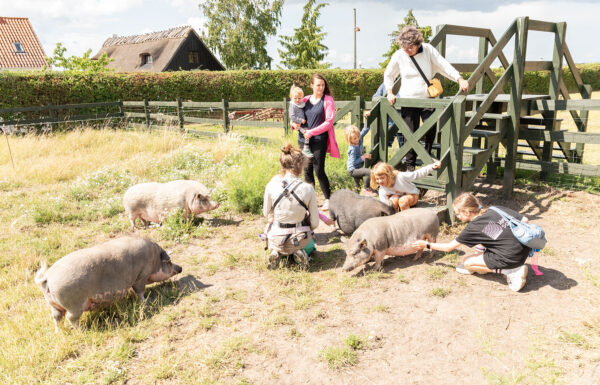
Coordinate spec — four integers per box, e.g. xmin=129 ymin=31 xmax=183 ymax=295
xmin=0 ymin=63 xmax=600 ymax=107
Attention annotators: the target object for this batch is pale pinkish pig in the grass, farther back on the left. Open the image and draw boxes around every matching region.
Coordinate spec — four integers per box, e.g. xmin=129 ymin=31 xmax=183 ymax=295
xmin=123 ymin=180 xmax=219 ymax=229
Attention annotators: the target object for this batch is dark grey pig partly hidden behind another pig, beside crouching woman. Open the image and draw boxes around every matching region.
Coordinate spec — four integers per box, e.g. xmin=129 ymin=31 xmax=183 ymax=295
xmin=329 ymin=190 xmax=394 ymax=235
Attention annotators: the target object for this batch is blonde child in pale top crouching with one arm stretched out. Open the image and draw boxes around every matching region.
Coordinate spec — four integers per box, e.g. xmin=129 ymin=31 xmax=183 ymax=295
xmin=371 ymin=160 xmax=442 ymax=211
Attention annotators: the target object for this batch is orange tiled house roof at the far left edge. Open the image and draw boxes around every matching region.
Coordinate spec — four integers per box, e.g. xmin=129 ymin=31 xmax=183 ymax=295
xmin=0 ymin=16 xmax=47 ymax=69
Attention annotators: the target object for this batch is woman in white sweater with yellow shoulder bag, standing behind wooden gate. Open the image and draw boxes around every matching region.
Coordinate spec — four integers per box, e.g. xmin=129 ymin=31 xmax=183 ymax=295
xmin=383 ymin=25 xmax=469 ymax=171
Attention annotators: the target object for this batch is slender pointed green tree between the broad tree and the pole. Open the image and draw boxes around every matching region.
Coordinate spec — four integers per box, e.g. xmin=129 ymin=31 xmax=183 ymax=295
xmin=277 ymin=0 xmax=330 ymax=69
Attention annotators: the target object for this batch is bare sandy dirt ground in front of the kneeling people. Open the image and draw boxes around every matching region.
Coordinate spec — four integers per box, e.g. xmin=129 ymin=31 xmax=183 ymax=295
xmin=127 ymin=178 xmax=600 ymax=384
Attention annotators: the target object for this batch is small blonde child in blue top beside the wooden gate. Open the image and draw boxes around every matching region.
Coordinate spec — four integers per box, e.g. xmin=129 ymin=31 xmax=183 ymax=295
xmin=345 ymin=125 xmax=377 ymax=197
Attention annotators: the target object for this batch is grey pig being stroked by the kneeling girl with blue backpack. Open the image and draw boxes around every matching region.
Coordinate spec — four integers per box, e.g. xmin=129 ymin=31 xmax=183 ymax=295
xmin=342 ymin=208 xmax=440 ymax=271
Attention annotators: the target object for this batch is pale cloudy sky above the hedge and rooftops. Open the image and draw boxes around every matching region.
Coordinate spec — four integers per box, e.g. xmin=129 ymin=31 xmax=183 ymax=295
xmin=0 ymin=0 xmax=600 ymax=69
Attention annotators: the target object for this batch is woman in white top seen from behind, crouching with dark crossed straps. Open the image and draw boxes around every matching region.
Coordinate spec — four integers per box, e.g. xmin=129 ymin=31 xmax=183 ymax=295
xmin=263 ymin=143 xmax=319 ymax=269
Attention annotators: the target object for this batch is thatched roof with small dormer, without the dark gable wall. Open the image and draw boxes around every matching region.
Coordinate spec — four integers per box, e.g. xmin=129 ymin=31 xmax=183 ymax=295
xmin=94 ymin=26 xmax=225 ymax=72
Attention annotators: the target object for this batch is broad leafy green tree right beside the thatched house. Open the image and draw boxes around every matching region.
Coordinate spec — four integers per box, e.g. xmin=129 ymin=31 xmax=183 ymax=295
xmin=199 ymin=0 xmax=284 ymax=69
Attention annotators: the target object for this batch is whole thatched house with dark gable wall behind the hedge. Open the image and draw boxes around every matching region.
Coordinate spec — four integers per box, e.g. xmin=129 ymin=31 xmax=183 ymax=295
xmin=94 ymin=26 xmax=225 ymax=72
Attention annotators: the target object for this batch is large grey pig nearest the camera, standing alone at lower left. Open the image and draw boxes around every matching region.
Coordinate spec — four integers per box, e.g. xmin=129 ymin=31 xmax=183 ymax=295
xmin=35 ymin=236 xmax=182 ymax=331
